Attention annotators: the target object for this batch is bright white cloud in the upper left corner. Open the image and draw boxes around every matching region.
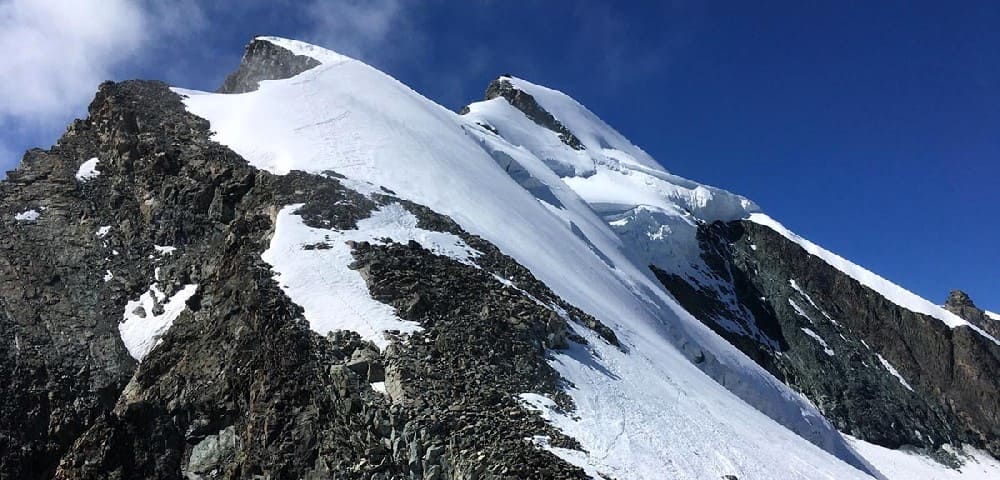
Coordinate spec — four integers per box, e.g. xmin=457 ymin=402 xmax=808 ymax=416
xmin=0 ymin=0 xmax=204 ymax=125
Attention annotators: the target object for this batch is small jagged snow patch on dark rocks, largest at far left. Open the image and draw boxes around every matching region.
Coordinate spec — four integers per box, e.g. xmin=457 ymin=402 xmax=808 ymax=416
xmin=118 ymin=283 xmax=198 ymax=362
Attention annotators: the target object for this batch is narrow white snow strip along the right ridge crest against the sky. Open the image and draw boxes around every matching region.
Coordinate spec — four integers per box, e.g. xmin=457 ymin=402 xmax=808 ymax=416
xmin=749 ymin=212 xmax=1000 ymax=345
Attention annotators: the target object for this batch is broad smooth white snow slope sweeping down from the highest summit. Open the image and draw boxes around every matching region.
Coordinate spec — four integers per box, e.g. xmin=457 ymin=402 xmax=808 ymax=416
xmin=180 ymin=35 xmax=880 ymax=476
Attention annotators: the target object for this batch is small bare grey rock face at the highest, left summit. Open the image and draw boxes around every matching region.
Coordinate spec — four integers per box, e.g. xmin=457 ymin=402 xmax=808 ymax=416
xmin=218 ymin=40 xmax=319 ymax=93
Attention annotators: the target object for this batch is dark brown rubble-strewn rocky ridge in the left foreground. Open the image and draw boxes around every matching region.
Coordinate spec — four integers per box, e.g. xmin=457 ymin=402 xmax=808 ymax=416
xmin=0 ymin=42 xmax=617 ymax=479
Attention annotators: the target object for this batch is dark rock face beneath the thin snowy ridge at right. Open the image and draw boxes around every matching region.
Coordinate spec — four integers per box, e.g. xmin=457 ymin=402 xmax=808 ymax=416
xmin=654 ymin=221 xmax=1000 ymax=455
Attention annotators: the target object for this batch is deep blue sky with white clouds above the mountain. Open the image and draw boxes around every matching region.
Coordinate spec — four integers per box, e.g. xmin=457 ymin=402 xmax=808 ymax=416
xmin=0 ymin=0 xmax=1000 ymax=311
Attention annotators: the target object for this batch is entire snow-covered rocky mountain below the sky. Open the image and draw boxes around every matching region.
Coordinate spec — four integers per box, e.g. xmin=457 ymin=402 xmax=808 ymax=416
xmin=0 ymin=37 xmax=1000 ymax=479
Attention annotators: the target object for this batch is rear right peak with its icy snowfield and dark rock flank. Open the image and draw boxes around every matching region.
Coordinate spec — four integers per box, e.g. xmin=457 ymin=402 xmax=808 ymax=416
xmin=463 ymin=71 xmax=1000 ymax=476
